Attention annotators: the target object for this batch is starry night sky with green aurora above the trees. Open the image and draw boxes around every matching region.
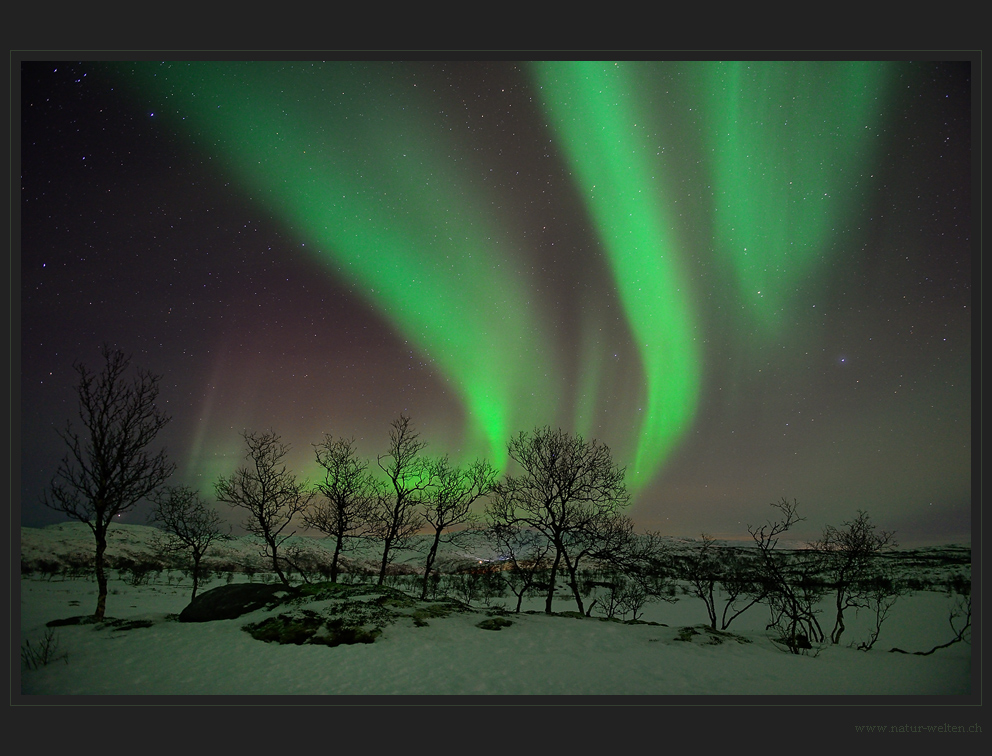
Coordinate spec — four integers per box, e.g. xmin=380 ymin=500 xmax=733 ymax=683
xmin=19 ymin=60 xmax=977 ymax=545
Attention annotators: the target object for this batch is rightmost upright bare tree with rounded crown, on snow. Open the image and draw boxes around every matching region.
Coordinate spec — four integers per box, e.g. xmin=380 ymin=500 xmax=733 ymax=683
xmin=810 ymin=510 xmax=896 ymax=644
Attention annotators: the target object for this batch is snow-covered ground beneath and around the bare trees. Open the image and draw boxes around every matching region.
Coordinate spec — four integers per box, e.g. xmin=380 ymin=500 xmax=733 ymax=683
xmin=15 ymin=529 xmax=977 ymax=702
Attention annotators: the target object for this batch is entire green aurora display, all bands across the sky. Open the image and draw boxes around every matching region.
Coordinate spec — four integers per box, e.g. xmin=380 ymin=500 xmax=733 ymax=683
xmin=117 ymin=62 xmax=900 ymax=502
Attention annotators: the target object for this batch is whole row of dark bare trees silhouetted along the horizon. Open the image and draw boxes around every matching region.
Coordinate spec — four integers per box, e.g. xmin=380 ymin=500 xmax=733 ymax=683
xmin=43 ymin=346 xmax=970 ymax=653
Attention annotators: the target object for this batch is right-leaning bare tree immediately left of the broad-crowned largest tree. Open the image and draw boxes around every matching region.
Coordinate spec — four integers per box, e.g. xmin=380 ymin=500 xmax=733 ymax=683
xmin=420 ymin=457 xmax=496 ymax=599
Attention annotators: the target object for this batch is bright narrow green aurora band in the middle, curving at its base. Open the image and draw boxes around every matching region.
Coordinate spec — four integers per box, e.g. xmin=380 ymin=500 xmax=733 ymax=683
xmin=533 ymin=61 xmax=702 ymax=492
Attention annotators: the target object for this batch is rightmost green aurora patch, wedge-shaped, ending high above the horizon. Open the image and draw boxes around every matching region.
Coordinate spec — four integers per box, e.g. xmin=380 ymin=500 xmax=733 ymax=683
xmin=686 ymin=61 xmax=889 ymax=340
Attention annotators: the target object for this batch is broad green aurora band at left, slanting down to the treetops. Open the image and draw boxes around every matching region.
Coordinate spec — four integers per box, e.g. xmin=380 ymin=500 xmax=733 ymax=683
xmin=121 ymin=63 xmax=559 ymax=478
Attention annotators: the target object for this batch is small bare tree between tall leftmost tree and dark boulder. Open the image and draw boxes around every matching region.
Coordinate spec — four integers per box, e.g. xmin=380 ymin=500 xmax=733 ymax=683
xmin=152 ymin=486 xmax=230 ymax=601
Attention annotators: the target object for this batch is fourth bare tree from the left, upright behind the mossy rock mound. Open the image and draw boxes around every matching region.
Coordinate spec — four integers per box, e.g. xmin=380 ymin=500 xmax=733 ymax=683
xmin=303 ymin=435 xmax=379 ymax=582
